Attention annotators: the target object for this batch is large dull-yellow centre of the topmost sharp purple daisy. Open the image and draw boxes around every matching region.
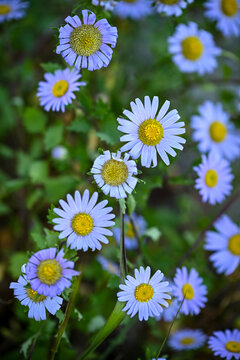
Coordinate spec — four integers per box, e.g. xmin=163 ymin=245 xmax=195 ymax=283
xmin=70 ymin=24 xmax=102 ymax=56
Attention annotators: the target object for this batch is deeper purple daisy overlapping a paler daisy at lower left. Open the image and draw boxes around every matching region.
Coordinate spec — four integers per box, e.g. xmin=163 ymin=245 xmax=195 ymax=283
xmin=26 ymin=248 xmax=79 ymax=296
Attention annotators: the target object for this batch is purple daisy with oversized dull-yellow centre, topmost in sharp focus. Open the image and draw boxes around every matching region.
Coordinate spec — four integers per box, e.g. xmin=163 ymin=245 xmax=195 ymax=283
xmin=56 ymin=10 xmax=118 ymax=71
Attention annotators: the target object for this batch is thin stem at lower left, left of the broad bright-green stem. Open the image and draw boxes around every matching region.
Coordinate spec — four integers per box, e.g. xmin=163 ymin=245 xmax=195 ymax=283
xmin=50 ymin=274 xmax=82 ymax=360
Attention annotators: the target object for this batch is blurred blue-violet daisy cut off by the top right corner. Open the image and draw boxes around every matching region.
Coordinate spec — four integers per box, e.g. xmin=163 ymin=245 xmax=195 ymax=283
xmin=204 ymin=0 xmax=240 ymax=37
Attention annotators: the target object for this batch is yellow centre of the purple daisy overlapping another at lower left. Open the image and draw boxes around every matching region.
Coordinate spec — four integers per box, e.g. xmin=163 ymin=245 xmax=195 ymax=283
xmin=37 ymin=259 xmax=62 ymax=285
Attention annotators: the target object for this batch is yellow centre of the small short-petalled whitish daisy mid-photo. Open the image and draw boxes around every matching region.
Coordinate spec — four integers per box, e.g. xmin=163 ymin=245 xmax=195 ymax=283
xmin=101 ymin=159 xmax=128 ymax=186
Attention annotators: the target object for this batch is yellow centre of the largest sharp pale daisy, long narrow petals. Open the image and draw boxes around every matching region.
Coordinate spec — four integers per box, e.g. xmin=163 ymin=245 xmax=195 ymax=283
xmin=138 ymin=119 xmax=163 ymax=146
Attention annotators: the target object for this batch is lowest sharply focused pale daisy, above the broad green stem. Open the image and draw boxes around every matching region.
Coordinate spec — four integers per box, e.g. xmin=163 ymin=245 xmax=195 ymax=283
xmin=117 ymin=266 xmax=171 ymax=321
